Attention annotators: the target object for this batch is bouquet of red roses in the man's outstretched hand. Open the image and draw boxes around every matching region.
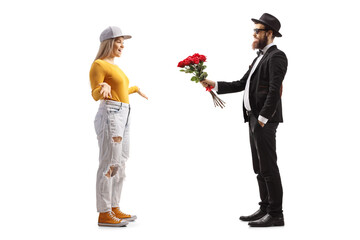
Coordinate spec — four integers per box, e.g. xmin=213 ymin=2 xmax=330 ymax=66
xmin=178 ymin=53 xmax=225 ymax=108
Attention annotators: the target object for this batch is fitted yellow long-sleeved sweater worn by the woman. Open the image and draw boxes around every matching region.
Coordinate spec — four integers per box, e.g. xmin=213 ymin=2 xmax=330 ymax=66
xmin=90 ymin=59 xmax=139 ymax=103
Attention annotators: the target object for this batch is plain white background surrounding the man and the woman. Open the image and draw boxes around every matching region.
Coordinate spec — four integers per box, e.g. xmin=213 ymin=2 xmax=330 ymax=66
xmin=0 ymin=0 xmax=360 ymax=239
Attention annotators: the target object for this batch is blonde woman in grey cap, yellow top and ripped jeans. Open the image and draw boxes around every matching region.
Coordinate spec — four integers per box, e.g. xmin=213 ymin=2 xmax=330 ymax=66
xmin=90 ymin=27 xmax=147 ymax=227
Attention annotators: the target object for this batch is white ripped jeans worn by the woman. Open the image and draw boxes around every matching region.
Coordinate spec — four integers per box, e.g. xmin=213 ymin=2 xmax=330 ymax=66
xmin=94 ymin=100 xmax=130 ymax=212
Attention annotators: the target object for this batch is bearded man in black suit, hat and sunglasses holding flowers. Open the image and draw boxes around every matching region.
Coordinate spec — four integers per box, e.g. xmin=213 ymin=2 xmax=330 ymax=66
xmin=201 ymin=13 xmax=287 ymax=227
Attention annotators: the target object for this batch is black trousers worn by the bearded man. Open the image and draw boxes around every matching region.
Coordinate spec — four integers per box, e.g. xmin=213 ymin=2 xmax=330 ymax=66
xmin=249 ymin=113 xmax=283 ymax=217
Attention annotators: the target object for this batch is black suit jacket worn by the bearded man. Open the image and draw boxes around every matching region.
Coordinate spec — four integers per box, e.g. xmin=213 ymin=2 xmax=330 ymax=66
xmin=217 ymin=45 xmax=288 ymax=122
